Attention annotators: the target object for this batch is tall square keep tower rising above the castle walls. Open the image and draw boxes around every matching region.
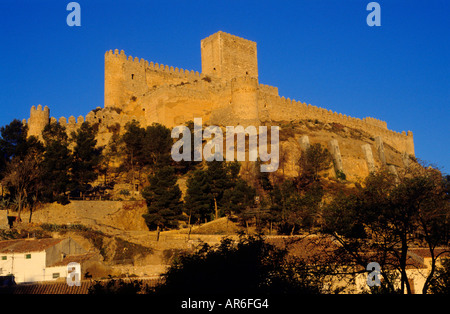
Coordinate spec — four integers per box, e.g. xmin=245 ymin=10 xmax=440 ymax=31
xmin=201 ymin=32 xmax=258 ymax=81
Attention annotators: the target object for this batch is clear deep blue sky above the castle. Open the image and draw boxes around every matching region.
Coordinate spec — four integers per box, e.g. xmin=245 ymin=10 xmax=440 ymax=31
xmin=0 ymin=0 xmax=450 ymax=173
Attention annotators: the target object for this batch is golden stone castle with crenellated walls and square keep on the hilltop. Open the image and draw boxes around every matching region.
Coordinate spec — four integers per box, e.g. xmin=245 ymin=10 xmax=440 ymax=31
xmin=24 ymin=32 xmax=414 ymax=182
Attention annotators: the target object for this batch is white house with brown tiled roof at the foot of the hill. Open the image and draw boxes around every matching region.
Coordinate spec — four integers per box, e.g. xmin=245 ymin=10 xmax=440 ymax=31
xmin=0 ymin=238 xmax=89 ymax=283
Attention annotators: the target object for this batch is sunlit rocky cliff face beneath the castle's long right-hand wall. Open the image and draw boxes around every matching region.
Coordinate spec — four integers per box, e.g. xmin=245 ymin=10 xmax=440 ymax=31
xmin=278 ymin=120 xmax=411 ymax=183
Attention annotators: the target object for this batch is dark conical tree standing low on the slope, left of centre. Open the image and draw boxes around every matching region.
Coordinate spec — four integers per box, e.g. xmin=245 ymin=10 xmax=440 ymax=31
xmin=142 ymin=166 xmax=184 ymax=231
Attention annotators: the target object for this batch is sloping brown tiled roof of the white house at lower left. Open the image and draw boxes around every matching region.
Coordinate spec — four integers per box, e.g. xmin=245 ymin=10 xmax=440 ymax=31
xmin=0 ymin=238 xmax=64 ymax=253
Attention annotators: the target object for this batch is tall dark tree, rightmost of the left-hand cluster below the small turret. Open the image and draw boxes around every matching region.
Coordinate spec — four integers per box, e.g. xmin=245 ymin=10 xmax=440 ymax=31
xmin=71 ymin=122 xmax=101 ymax=194
